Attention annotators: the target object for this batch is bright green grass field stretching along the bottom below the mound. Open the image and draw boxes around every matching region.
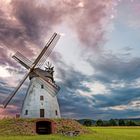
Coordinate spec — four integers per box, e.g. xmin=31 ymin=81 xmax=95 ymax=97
xmin=0 ymin=127 xmax=140 ymax=140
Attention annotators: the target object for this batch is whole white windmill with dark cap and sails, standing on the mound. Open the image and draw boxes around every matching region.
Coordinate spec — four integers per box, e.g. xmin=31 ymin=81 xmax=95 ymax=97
xmin=3 ymin=33 xmax=61 ymax=118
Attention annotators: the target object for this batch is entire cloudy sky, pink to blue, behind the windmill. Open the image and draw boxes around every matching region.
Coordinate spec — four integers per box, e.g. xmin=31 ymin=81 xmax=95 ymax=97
xmin=0 ymin=0 xmax=140 ymax=119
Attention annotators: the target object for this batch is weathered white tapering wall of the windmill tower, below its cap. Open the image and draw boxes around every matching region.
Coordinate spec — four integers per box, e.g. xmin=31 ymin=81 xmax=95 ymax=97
xmin=21 ymin=77 xmax=61 ymax=118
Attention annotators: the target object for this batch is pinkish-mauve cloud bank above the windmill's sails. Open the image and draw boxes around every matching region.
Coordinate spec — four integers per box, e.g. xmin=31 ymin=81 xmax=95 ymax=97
xmin=0 ymin=0 xmax=114 ymax=65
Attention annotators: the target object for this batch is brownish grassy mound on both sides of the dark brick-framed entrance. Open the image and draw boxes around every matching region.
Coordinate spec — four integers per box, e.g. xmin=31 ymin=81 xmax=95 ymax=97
xmin=0 ymin=118 xmax=88 ymax=135
